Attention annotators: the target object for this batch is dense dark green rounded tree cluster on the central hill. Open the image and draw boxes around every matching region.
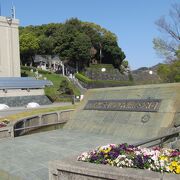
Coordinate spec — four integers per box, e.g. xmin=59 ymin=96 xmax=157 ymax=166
xmin=19 ymin=18 xmax=126 ymax=70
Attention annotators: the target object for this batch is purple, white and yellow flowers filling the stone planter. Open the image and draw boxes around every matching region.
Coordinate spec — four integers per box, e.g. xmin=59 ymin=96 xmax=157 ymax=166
xmin=78 ymin=144 xmax=180 ymax=174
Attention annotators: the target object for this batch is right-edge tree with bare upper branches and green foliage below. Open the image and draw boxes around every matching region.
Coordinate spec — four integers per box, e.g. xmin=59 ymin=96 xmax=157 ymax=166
xmin=153 ymin=4 xmax=180 ymax=82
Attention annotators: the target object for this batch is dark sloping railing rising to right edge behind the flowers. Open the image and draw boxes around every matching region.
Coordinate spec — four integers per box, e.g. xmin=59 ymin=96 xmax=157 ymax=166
xmin=133 ymin=128 xmax=180 ymax=147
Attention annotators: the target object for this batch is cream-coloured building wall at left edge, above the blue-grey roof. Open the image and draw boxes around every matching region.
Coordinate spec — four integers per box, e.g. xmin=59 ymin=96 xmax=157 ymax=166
xmin=0 ymin=16 xmax=20 ymax=77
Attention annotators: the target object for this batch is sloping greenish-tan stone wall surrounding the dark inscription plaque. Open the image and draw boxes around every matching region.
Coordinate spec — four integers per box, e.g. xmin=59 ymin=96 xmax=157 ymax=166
xmin=64 ymin=83 xmax=180 ymax=143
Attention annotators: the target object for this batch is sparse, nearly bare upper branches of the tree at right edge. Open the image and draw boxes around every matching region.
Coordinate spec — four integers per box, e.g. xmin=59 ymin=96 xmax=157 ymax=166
xmin=153 ymin=3 xmax=180 ymax=61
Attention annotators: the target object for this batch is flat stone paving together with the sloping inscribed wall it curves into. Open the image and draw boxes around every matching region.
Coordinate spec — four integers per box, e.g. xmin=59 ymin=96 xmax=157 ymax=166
xmin=0 ymin=83 xmax=180 ymax=180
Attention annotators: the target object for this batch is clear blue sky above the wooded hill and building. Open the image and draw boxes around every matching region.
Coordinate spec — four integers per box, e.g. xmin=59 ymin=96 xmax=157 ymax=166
xmin=0 ymin=0 xmax=178 ymax=69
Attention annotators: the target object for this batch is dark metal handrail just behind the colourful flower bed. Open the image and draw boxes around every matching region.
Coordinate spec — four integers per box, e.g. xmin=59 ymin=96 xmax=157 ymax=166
xmin=133 ymin=129 xmax=180 ymax=147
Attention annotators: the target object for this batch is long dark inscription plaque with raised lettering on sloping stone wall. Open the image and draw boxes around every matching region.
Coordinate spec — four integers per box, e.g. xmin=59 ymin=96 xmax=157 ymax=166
xmin=84 ymin=99 xmax=161 ymax=112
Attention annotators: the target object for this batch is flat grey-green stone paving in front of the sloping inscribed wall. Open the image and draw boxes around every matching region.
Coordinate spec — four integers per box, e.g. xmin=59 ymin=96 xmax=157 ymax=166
xmin=0 ymin=129 xmax=132 ymax=180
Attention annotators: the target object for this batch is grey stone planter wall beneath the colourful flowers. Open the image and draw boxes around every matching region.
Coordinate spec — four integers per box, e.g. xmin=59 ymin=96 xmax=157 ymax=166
xmin=49 ymin=158 xmax=179 ymax=180
